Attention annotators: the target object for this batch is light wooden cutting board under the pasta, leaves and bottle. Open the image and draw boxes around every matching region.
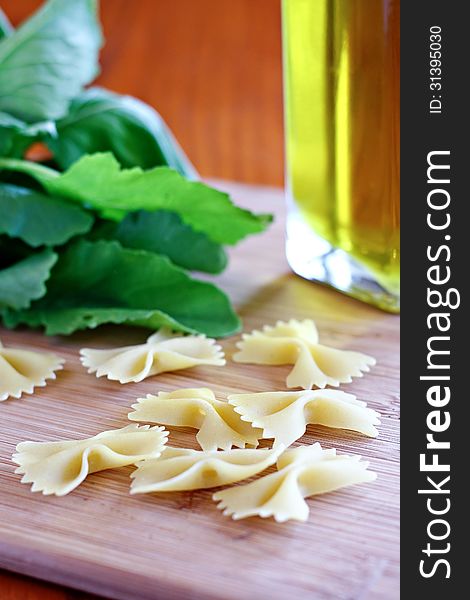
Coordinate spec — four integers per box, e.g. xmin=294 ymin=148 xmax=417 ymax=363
xmin=0 ymin=183 xmax=399 ymax=600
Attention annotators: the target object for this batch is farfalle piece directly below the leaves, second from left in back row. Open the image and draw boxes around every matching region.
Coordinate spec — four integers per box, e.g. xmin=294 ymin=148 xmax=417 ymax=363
xmin=80 ymin=328 xmax=225 ymax=383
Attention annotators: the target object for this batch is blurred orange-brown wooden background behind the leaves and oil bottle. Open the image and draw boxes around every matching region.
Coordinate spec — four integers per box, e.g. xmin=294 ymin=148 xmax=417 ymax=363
xmin=0 ymin=0 xmax=283 ymax=185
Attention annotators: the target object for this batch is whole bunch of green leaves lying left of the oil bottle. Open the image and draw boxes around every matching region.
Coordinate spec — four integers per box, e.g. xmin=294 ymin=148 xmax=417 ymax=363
xmin=0 ymin=0 xmax=270 ymax=336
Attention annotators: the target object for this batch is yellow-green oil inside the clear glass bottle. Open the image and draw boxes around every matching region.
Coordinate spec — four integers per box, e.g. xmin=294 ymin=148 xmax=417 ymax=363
xmin=283 ymin=0 xmax=400 ymax=294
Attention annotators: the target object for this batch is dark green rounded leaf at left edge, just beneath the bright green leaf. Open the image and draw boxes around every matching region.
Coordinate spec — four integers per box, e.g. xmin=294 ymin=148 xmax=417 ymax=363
xmin=0 ymin=183 xmax=93 ymax=247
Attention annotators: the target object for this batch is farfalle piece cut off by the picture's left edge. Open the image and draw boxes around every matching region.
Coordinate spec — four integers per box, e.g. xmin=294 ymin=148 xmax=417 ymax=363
xmin=0 ymin=342 xmax=65 ymax=402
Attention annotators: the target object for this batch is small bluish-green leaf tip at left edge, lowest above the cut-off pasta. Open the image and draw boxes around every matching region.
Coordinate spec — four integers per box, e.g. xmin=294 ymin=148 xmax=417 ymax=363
xmin=0 ymin=248 xmax=57 ymax=310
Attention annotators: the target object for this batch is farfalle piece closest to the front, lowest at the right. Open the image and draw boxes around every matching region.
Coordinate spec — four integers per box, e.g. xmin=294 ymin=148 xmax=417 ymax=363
xmin=212 ymin=443 xmax=377 ymax=523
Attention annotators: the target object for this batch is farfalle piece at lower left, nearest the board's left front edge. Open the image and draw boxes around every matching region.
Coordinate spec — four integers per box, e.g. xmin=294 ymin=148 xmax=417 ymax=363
xmin=12 ymin=424 xmax=168 ymax=496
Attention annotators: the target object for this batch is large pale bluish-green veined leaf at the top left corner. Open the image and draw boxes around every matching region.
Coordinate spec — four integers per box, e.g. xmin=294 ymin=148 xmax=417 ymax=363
xmin=0 ymin=0 xmax=101 ymax=123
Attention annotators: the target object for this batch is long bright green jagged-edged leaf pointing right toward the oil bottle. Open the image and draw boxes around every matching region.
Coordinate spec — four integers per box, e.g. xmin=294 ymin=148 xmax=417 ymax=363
xmin=0 ymin=152 xmax=272 ymax=244
